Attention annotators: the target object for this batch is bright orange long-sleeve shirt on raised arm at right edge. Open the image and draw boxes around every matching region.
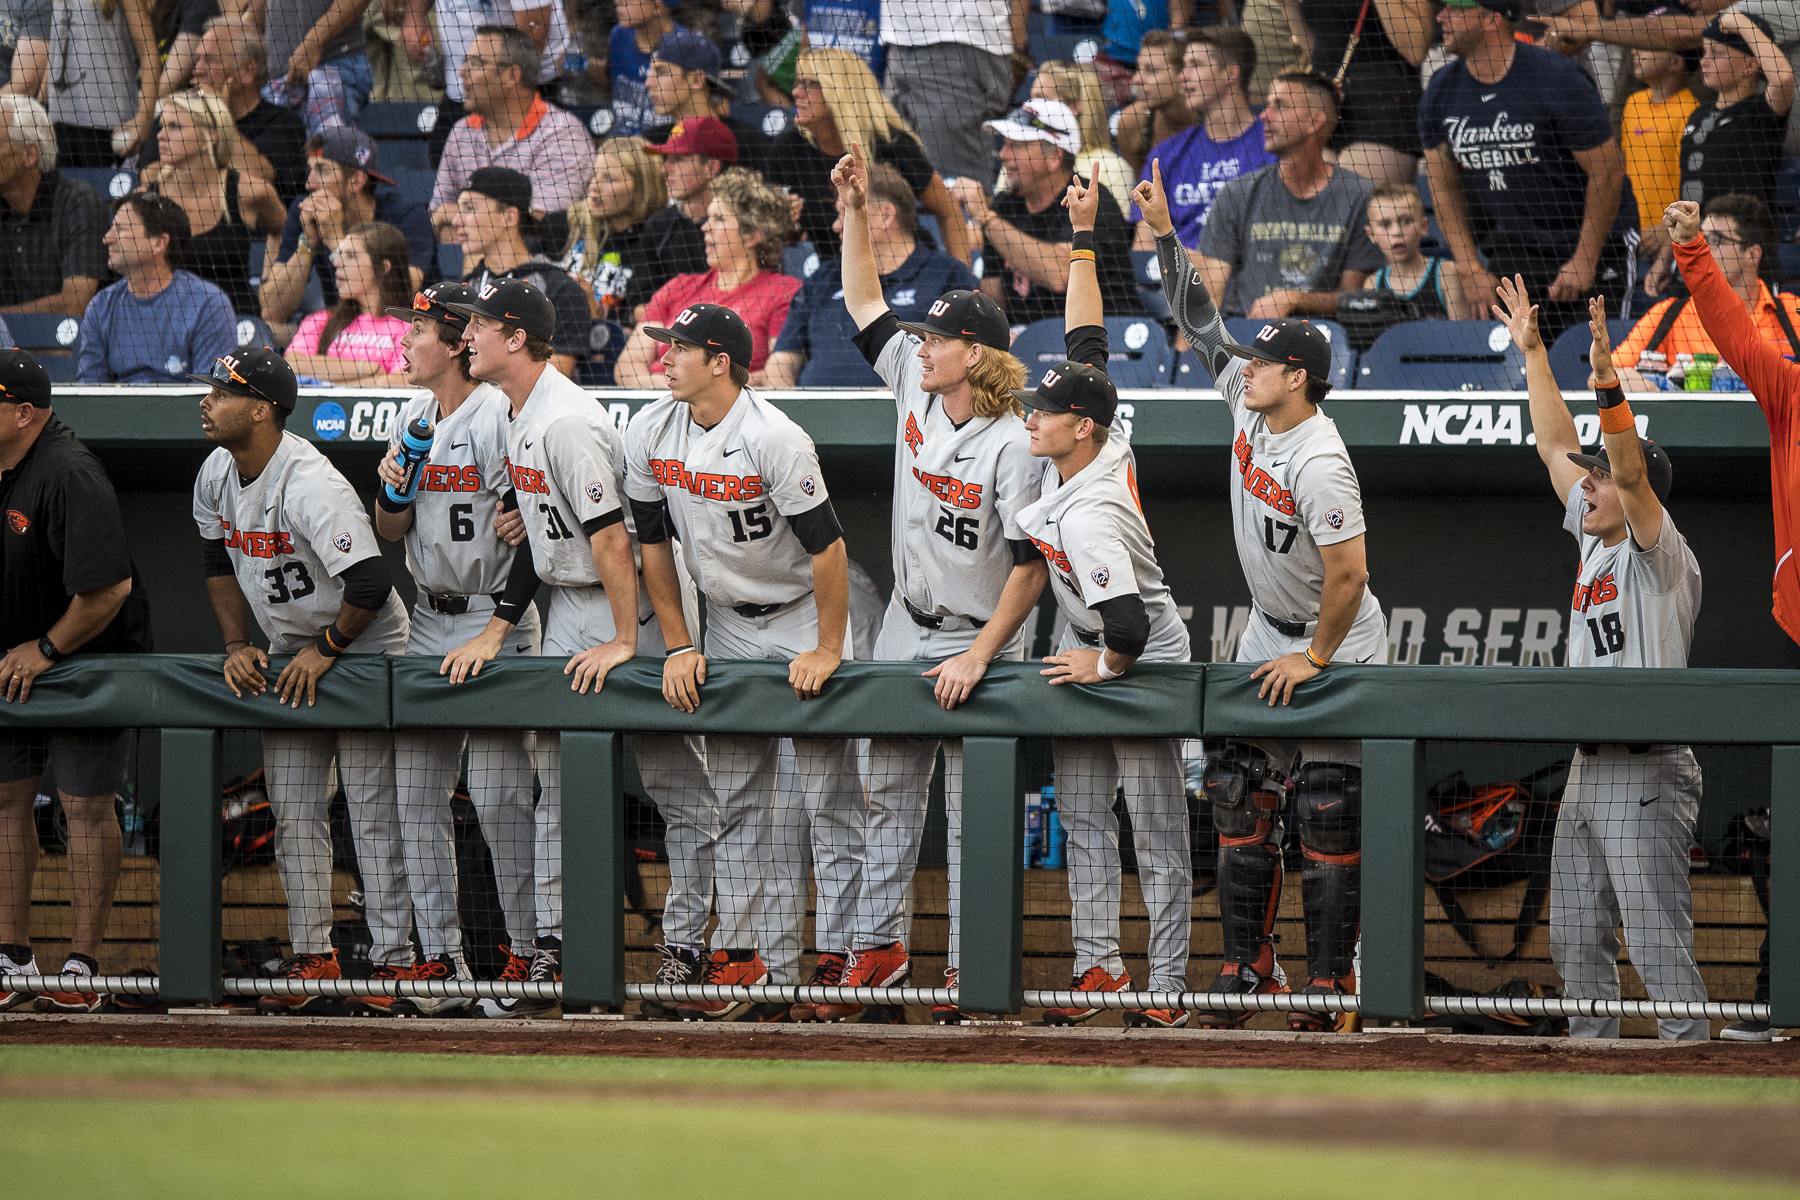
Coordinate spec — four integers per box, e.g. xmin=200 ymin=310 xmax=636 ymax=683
xmin=1676 ymin=237 xmax=1800 ymax=642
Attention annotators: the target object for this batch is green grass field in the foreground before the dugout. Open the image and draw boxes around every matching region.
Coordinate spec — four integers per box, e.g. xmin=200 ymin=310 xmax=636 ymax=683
xmin=0 ymin=1047 xmax=1800 ymax=1200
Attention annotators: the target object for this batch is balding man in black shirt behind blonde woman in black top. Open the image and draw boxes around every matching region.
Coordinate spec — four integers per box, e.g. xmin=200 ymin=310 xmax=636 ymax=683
xmin=137 ymin=16 xmax=306 ymax=205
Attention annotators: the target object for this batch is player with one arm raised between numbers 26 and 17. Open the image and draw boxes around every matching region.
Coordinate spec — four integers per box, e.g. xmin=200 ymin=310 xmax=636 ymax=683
xmin=1019 ymin=170 xmax=1193 ymax=1027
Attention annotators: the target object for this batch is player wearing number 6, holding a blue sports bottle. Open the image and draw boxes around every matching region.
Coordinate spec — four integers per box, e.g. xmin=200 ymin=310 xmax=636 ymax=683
xmin=349 ymin=282 xmax=542 ymax=1016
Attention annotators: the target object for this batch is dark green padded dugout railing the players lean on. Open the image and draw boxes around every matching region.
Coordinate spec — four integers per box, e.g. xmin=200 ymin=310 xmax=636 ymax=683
xmin=0 ymin=655 xmax=1800 ymax=1027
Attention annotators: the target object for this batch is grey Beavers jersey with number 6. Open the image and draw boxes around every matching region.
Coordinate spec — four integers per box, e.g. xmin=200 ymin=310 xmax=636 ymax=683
xmin=387 ymin=383 xmax=513 ymax=596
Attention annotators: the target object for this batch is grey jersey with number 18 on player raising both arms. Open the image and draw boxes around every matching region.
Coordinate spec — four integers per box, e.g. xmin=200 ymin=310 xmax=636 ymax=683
xmin=1562 ymin=480 xmax=1699 ymax=667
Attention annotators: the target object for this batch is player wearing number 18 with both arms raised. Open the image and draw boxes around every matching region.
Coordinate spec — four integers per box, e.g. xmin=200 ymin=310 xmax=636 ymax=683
xmin=1499 ymin=277 xmax=1710 ymax=1042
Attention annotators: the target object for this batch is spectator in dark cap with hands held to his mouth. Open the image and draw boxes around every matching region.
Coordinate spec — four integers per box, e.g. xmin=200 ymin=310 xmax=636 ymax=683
xmin=261 ymin=128 xmax=437 ymax=336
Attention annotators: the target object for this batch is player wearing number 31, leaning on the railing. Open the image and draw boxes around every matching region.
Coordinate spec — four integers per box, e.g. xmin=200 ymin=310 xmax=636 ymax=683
xmin=434 ymin=279 xmax=718 ymax=1018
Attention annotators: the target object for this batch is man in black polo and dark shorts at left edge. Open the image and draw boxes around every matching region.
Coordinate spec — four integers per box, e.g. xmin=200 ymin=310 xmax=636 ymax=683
xmin=0 ymin=351 xmax=149 ymax=1013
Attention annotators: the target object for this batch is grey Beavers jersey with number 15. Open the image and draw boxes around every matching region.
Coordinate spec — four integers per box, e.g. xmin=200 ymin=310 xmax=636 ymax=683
xmin=625 ymin=389 xmax=830 ymax=608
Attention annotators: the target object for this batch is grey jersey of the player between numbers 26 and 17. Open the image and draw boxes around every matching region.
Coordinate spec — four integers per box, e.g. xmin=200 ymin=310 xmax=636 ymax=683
xmin=1019 ymin=430 xmax=1188 ymax=662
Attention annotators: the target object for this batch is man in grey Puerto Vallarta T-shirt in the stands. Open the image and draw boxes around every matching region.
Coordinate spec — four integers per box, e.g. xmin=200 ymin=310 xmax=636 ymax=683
xmin=1193 ymin=68 xmax=1382 ymax=318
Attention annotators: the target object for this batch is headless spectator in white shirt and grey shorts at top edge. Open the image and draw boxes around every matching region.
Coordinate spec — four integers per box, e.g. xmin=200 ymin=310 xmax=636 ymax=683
xmin=882 ymin=0 xmax=1031 ymax=187
